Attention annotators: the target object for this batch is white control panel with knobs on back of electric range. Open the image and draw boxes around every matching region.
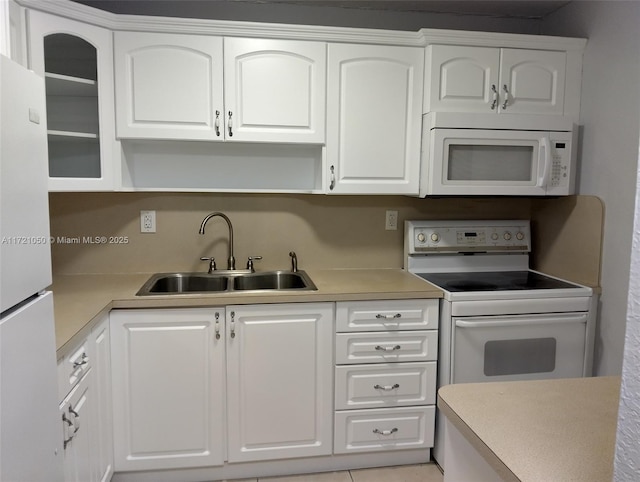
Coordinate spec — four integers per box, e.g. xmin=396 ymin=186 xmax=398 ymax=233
xmin=405 ymin=220 xmax=531 ymax=254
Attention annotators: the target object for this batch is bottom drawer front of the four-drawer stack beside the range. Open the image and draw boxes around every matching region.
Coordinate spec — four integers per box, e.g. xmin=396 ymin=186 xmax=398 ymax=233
xmin=334 ymin=405 xmax=436 ymax=454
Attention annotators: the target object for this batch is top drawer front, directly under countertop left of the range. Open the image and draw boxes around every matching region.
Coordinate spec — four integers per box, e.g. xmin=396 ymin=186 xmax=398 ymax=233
xmin=336 ymin=299 xmax=438 ymax=332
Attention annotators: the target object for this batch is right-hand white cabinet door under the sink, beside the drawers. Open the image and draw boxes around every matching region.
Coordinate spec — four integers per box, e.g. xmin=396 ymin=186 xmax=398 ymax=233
xmin=227 ymin=303 xmax=333 ymax=462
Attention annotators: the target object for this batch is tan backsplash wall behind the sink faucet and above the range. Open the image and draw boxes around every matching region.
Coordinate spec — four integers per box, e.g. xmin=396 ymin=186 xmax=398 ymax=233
xmin=50 ymin=193 xmax=601 ymax=284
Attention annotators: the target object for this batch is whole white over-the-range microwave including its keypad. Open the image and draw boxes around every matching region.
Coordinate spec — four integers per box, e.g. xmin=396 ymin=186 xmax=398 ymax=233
xmin=420 ymin=113 xmax=576 ymax=196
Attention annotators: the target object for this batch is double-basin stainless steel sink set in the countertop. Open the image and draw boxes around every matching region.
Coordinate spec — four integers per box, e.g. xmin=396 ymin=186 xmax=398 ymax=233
xmin=136 ymin=271 xmax=317 ymax=296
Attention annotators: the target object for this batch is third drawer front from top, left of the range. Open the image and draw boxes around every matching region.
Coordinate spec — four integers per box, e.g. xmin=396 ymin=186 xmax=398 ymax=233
xmin=336 ymin=362 xmax=437 ymax=410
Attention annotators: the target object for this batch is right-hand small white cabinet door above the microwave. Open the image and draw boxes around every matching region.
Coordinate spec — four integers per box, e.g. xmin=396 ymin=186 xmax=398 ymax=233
xmin=500 ymin=49 xmax=567 ymax=115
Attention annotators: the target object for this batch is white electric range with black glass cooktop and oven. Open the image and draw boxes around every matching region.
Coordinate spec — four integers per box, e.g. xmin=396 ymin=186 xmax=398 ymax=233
xmin=405 ymin=220 xmax=596 ymax=468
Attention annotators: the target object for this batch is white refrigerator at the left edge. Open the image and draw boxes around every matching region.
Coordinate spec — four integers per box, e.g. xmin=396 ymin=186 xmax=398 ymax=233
xmin=0 ymin=55 xmax=63 ymax=482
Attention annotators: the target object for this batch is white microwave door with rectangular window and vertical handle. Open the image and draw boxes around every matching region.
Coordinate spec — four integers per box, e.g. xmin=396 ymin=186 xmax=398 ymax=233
xmin=428 ymin=129 xmax=550 ymax=196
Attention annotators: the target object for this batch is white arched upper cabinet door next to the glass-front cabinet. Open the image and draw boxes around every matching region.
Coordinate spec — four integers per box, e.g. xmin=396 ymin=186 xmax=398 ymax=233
xmin=114 ymin=32 xmax=224 ymax=140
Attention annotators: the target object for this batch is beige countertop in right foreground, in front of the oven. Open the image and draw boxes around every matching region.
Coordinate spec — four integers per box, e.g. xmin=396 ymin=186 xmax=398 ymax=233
xmin=438 ymin=377 xmax=620 ymax=482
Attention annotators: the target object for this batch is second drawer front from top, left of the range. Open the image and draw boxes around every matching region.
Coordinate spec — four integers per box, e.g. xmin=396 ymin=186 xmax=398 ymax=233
xmin=336 ymin=330 xmax=438 ymax=365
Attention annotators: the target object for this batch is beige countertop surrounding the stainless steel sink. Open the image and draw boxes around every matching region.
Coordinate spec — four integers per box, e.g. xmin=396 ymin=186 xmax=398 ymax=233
xmin=50 ymin=269 xmax=442 ymax=359
